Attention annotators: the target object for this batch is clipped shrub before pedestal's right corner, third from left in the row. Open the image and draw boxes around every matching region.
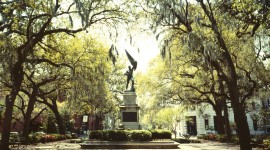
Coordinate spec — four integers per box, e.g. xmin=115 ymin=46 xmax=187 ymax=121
xmin=130 ymin=130 xmax=152 ymax=141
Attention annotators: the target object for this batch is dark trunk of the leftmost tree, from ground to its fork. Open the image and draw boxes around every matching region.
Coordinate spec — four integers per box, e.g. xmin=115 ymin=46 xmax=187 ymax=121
xmin=1 ymin=62 xmax=23 ymax=150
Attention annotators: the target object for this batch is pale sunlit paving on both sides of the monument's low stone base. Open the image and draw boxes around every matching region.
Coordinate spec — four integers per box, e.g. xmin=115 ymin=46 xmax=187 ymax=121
xmin=12 ymin=141 xmax=262 ymax=150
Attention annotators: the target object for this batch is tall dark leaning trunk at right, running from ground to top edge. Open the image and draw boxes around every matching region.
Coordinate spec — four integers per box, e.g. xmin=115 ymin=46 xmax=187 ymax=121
xmin=199 ymin=0 xmax=252 ymax=150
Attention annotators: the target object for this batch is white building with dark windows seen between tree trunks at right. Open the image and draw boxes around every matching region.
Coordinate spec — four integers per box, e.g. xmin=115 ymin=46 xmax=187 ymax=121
xmin=176 ymin=99 xmax=270 ymax=136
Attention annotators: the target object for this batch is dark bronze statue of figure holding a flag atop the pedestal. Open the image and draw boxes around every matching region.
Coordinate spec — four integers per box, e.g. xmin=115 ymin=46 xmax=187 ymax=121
xmin=125 ymin=50 xmax=137 ymax=91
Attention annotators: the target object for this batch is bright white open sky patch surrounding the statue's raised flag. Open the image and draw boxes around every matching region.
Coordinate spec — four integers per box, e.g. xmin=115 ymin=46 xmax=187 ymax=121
xmin=90 ymin=24 xmax=160 ymax=73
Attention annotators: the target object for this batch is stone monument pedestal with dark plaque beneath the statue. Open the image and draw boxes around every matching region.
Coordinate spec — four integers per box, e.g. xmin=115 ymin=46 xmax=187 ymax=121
xmin=120 ymin=91 xmax=141 ymax=130
